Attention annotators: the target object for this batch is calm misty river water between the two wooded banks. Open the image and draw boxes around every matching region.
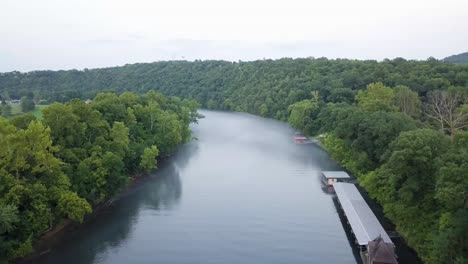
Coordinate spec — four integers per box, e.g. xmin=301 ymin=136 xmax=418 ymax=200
xmin=34 ymin=111 xmax=420 ymax=264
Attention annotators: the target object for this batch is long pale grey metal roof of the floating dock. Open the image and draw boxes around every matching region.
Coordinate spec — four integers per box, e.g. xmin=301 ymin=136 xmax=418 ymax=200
xmin=333 ymin=182 xmax=393 ymax=246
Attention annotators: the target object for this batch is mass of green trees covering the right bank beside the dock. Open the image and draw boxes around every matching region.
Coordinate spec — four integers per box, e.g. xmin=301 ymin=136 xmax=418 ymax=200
xmin=288 ymin=83 xmax=468 ymax=264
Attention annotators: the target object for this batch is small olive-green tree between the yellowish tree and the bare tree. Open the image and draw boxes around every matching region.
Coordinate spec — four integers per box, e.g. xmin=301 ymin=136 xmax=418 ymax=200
xmin=393 ymin=85 xmax=421 ymax=118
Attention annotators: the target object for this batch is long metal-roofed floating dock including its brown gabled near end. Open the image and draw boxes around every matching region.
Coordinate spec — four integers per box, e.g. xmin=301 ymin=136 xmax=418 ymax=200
xmin=333 ymin=182 xmax=398 ymax=264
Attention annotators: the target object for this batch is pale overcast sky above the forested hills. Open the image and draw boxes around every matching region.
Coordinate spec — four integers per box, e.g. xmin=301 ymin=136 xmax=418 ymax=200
xmin=0 ymin=0 xmax=468 ymax=72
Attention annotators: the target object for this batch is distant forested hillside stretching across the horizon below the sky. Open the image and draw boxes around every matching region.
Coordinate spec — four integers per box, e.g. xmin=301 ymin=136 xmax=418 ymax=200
xmin=0 ymin=58 xmax=468 ymax=117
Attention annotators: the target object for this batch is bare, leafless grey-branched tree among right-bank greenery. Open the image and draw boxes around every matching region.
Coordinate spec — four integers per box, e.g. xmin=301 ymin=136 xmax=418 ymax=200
xmin=425 ymin=91 xmax=468 ymax=135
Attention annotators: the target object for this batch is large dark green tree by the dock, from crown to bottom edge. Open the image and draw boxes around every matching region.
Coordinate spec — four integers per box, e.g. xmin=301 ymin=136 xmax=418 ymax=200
xmin=362 ymin=129 xmax=450 ymax=263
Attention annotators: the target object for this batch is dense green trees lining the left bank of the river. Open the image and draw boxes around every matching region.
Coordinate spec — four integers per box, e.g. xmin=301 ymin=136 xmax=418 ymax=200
xmin=0 ymin=91 xmax=199 ymax=262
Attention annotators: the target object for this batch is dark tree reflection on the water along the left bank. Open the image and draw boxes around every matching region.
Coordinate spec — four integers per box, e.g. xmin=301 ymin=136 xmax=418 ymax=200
xmin=29 ymin=161 xmax=185 ymax=264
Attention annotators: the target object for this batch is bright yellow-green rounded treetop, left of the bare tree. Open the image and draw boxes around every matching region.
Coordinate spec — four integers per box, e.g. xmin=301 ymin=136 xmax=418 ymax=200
xmin=356 ymin=82 xmax=396 ymax=112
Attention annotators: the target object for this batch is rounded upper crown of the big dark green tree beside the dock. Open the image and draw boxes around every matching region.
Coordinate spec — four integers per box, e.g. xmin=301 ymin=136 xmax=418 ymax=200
xmin=363 ymin=129 xmax=449 ymax=206
